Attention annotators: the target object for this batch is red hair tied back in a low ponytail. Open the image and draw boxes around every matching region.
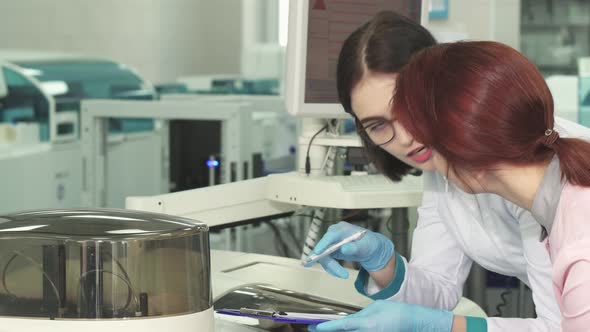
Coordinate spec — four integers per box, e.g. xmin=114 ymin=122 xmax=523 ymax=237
xmin=393 ymin=41 xmax=590 ymax=186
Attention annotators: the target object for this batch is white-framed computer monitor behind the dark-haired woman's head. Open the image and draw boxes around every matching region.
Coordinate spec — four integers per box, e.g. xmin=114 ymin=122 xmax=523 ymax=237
xmin=285 ymin=0 xmax=428 ymax=119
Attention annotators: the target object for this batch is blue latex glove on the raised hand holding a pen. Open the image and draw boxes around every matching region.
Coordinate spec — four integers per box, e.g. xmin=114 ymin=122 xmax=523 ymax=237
xmin=306 ymin=221 xmax=395 ymax=279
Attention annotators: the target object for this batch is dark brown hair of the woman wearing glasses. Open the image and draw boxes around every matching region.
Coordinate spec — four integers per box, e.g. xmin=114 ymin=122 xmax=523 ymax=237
xmin=336 ymin=11 xmax=436 ymax=181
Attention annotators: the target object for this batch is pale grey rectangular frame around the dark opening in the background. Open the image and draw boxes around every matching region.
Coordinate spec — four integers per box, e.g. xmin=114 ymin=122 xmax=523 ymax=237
xmin=81 ymin=100 xmax=252 ymax=207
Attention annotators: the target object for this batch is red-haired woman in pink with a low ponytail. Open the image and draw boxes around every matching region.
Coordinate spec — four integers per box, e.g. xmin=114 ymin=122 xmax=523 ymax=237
xmin=393 ymin=42 xmax=590 ymax=331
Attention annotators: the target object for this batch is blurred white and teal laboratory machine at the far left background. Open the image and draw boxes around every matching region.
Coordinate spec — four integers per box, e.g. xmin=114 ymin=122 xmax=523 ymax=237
xmin=0 ymin=51 xmax=166 ymax=213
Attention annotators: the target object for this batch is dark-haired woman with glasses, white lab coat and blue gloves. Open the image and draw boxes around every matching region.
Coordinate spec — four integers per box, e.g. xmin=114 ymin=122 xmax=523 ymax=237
xmin=314 ymin=12 xmax=590 ymax=332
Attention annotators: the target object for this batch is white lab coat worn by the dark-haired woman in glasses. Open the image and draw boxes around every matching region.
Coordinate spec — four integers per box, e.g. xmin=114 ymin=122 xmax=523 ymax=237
xmin=367 ymin=119 xmax=590 ymax=332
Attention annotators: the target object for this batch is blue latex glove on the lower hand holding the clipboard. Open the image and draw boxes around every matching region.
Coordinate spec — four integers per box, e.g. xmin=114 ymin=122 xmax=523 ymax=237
xmin=309 ymin=300 xmax=453 ymax=332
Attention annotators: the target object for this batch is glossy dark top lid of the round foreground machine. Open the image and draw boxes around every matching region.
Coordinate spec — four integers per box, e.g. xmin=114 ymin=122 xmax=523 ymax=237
xmin=0 ymin=209 xmax=208 ymax=241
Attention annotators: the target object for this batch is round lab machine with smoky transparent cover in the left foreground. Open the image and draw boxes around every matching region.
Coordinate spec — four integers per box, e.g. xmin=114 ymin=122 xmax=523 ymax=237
xmin=0 ymin=209 xmax=214 ymax=332
